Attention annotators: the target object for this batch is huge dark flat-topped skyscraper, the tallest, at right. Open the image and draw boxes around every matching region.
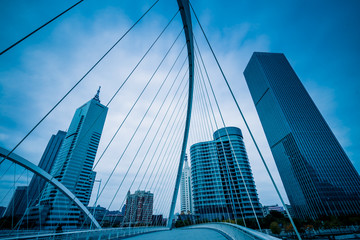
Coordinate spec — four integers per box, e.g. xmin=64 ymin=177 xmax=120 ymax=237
xmin=244 ymin=53 xmax=360 ymax=218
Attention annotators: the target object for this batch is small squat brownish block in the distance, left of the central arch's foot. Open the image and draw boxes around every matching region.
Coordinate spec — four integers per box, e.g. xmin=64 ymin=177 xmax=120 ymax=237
xmin=124 ymin=190 xmax=154 ymax=225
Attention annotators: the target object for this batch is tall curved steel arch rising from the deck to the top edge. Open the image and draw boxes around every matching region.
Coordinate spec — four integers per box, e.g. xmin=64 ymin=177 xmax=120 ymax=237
xmin=168 ymin=0 xmax=194 ymax=229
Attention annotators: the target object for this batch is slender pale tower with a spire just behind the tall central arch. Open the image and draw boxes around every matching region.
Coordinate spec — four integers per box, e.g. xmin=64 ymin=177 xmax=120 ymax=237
xmin=180 ymin=155 xmax=194 ymax=214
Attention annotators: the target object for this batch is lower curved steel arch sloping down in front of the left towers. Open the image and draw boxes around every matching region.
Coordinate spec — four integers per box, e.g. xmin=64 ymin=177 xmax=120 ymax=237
xmin=0 ymin=147 xmax=101 ymax=229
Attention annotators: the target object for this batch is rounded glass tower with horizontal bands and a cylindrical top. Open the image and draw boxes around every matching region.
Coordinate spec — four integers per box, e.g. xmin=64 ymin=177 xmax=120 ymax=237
xmin=190 ymin=127 xmax=263 ymax=220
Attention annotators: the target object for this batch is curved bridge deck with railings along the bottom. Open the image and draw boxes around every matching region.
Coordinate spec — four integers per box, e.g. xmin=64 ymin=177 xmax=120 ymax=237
xmin=0 ymin=223 xmax=279 ymax=240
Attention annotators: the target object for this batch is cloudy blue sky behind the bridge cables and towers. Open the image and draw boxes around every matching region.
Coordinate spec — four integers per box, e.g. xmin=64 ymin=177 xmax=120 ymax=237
xmin=0 ymin=0 xmax=360 ymax=218
